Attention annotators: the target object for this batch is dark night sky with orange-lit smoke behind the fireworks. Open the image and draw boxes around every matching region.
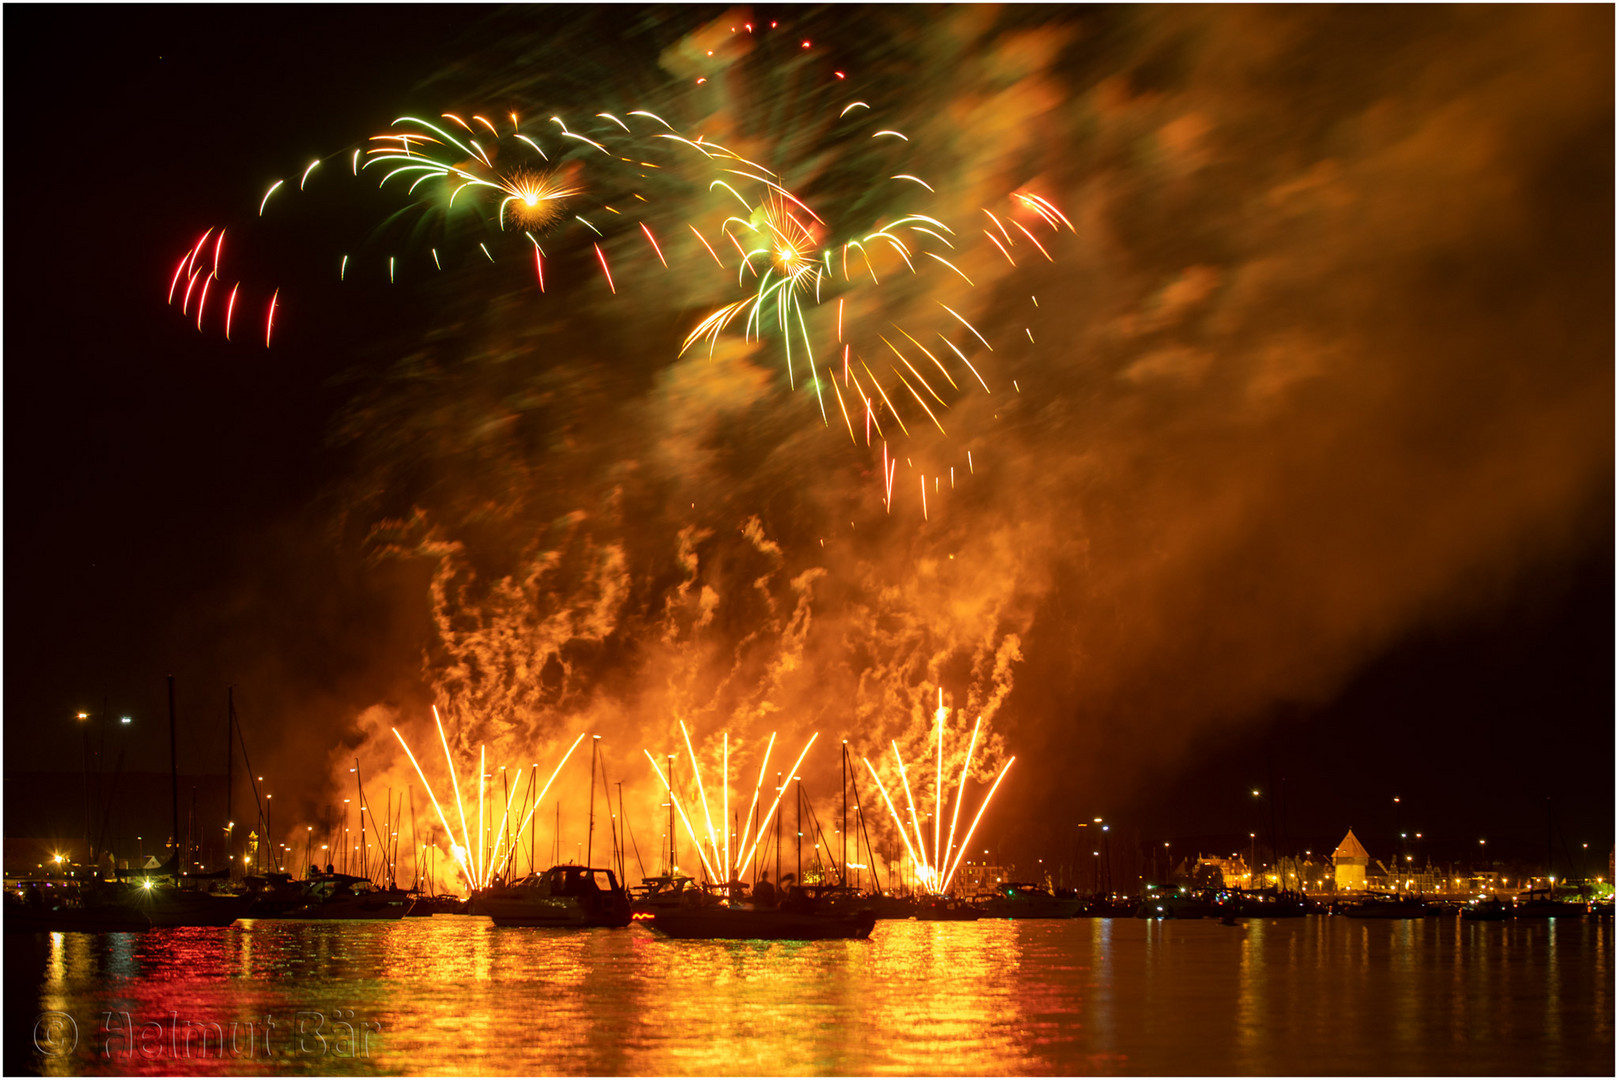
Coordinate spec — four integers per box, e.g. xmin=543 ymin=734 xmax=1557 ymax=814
xmin=5 ymin=6 xmax=1615 ymax=880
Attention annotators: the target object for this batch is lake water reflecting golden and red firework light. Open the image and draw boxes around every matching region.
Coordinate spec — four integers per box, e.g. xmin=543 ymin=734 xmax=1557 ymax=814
xmin=5 ymin=916 xmax=1613 ymax=1075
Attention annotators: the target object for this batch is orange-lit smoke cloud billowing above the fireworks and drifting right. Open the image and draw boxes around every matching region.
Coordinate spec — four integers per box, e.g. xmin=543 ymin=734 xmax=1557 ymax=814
xmin=265 ymin=8 xmax=1613 ymax=870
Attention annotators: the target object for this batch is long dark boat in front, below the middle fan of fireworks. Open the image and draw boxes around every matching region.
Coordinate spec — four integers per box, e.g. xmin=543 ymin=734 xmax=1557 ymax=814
xmin=650 ymin=886 xmax=877 ymax=941
